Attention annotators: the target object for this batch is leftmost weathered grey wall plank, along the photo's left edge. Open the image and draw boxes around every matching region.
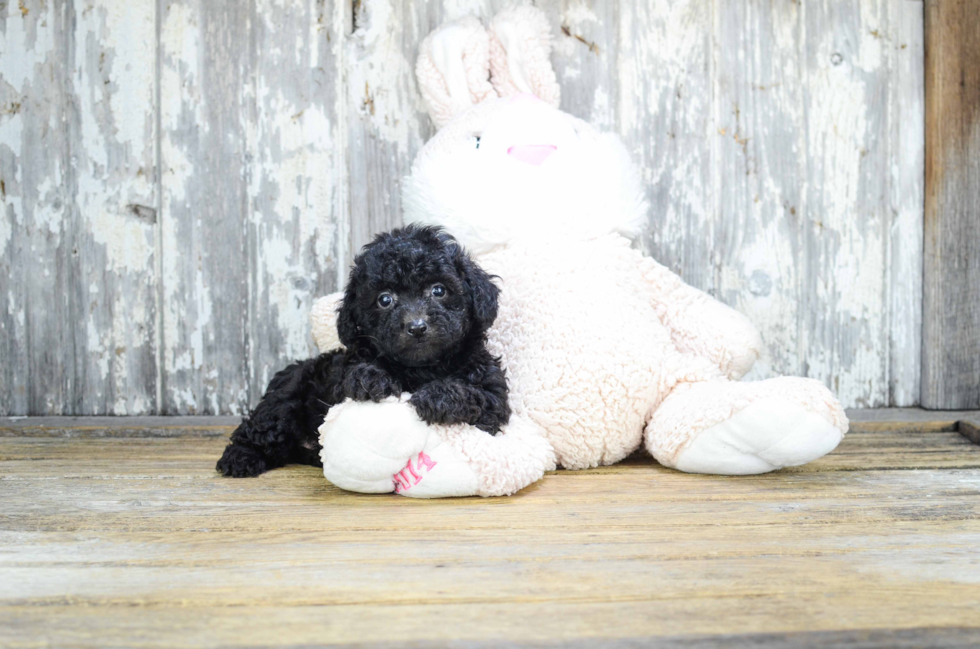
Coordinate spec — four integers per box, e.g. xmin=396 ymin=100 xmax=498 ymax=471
xmin=0 ymin=0 xmax=73 ymax=414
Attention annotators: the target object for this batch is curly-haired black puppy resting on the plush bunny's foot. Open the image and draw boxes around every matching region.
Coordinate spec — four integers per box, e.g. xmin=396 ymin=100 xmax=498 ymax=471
xmin=217 ymin=226 xmax=510 ymax=477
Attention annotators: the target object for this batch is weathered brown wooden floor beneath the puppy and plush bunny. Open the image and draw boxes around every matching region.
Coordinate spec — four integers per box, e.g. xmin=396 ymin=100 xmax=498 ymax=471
xmin=0 ymin=431 xmax=980 ymax=647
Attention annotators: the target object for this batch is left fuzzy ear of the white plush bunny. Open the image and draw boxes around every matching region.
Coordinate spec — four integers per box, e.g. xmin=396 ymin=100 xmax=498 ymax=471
xmin=415 ymin=16 xmax=497 ymax=128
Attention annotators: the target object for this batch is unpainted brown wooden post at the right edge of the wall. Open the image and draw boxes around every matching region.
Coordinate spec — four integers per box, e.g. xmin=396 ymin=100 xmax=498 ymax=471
xmin=922 ymin=0 xmax=980 ymax=409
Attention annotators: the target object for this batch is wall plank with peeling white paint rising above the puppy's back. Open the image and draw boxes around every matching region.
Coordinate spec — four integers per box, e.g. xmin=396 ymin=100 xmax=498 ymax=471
xmin=240 ymin=2 xmax=347 ymax=404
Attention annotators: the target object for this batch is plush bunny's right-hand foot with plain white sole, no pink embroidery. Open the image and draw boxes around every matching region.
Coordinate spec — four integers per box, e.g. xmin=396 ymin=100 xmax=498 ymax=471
xmin=646 ymin=377 xmax=847 ymax=475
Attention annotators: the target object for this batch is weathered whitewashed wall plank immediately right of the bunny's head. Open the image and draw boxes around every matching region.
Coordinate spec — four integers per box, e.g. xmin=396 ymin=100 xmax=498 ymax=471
xmin=617 ymin=0 xmax=714 ymax=292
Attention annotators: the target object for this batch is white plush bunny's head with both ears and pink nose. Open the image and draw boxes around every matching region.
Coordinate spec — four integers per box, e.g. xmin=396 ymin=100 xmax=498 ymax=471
xmin=404 ymin=7 xmax=646 ymax=254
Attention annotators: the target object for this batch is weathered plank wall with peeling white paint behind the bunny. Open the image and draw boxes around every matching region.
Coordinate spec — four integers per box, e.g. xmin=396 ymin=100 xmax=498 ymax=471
xmin=0 ymin=0 xmax=924 ymax=414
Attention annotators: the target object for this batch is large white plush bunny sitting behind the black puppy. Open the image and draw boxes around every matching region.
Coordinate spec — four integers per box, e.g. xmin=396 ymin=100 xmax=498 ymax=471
xmin=312 ymin=6 xmax=847 ymax=497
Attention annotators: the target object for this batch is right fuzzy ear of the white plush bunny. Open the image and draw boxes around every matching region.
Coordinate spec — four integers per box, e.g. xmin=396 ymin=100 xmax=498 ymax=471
xmin=490 ymin=5 xmax=561 ymax=108
